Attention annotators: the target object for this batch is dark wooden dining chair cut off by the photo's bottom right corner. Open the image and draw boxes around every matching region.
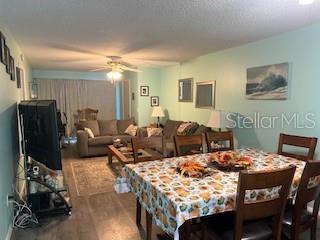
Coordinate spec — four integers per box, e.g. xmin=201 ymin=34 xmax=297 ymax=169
xmin=282 ymin=160 xmax=320 ymax=240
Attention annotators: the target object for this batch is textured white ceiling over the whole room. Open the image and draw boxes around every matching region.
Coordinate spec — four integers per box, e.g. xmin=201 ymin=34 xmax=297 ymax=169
xmin=0 ymin=0 xmax=320 ymax=70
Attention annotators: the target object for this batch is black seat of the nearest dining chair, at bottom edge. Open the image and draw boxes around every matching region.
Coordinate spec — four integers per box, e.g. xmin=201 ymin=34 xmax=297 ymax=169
xmin=206 ymin=213 xmax=272 ymax=240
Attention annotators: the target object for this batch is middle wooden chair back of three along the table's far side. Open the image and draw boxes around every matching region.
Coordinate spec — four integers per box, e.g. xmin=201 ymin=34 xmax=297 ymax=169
xmin=174 ymin=135 xmax=203 ymax=157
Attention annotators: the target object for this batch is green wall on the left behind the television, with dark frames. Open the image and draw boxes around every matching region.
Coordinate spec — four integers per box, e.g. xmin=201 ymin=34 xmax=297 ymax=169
xmin=0 ymin=24 xmax=31 ymax=239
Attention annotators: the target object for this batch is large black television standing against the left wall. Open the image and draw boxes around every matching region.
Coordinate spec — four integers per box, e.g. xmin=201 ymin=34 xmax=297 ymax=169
xmin=19 ymin=100 xmax=62 ymax=170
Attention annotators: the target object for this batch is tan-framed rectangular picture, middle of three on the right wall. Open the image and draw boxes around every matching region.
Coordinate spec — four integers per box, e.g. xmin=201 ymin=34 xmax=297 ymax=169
xmin=196 ymin=81 xmax=216 ymax=108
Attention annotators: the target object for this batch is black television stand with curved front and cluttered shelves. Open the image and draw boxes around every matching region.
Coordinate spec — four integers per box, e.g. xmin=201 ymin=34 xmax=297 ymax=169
xmin=27 ymin=165 xmax=72 ymax=218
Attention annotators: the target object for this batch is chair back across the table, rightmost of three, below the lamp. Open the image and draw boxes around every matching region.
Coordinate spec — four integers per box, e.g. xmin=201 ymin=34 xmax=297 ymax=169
xmin=206 ymin=131 xmax=234 ymax=152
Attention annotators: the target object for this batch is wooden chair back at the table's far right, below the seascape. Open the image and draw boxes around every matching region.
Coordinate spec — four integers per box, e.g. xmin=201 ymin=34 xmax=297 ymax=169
xmin=278 ymin=133 xmax=318 ymax=161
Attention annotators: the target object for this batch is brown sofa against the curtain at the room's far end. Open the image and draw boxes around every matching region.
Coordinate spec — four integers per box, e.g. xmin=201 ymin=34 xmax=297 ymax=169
xmin=77 ymin=119 xmax=134 ymax=157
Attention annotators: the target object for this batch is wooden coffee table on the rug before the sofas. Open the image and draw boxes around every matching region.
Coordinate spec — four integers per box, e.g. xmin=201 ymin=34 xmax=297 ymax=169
xmin=107 ymin=145 xmax=154 ymax=166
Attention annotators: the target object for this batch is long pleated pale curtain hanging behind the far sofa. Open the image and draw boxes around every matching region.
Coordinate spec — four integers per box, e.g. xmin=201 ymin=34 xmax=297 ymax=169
xmin=36 ymin=79 xmax=115 ymax=135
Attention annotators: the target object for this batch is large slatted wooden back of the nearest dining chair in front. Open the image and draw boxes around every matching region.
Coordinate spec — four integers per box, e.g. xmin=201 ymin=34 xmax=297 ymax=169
xmin=234 ymin=166 xmax=296 ymax=240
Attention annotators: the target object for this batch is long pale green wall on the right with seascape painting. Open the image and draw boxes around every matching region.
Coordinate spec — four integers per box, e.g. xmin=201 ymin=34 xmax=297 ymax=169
xmin=160 ymin=21 xmax=320 ymax=157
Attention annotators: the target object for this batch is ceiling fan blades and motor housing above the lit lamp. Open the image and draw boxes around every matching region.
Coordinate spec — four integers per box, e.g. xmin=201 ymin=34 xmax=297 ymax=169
xmin=90 ymin=56 xmax=141 ymax=73
